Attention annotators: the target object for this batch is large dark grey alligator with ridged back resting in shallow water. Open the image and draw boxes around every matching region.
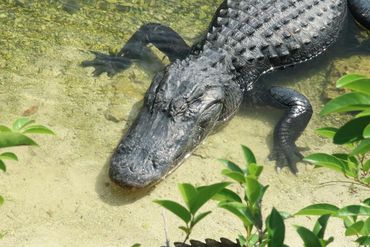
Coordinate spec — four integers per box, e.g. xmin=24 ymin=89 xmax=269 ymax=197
xmin=82 ymin=0 xmax=370 ymax=188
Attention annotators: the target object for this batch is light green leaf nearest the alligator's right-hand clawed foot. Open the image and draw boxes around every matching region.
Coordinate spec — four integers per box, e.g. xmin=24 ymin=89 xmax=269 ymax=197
xmin=303 ymin=153 xmax=345 ymax=172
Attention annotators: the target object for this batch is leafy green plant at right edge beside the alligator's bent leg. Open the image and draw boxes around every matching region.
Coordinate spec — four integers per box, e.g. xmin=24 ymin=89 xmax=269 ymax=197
xmin=304 ymin=75 xmax=370 ymax=187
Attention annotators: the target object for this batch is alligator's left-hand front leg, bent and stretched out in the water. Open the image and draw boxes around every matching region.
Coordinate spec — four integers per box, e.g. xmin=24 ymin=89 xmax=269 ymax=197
xmin=81 ymin=23 xmax=190 ymax=76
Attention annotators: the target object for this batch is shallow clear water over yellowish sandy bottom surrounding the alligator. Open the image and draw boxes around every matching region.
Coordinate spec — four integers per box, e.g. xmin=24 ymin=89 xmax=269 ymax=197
xmin=0 ymin=0 xmax=370 ymax=247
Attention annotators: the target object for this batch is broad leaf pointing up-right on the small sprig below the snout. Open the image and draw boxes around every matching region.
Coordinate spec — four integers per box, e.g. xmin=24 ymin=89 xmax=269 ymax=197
xmin=191 ymin=182 xmax=230 ymax=214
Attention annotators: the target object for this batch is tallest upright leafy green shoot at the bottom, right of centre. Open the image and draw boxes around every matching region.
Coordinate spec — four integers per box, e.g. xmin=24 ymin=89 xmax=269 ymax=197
xmin=215 ymin=146 xmax=285 ymax=247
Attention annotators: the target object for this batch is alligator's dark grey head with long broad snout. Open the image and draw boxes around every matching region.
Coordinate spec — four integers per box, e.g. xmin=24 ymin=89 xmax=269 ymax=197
xmin=109 ymin=52 xmax=242 ymax=188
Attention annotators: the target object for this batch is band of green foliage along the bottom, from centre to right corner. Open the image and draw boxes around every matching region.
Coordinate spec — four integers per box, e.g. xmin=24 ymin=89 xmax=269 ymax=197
xmin=155 ymin=146 xmax=370 ymax=247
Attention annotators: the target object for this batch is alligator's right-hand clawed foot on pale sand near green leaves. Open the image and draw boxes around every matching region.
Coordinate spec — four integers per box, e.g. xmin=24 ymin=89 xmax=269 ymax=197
xmin=268 ymin=145 xmax=303 ymax=175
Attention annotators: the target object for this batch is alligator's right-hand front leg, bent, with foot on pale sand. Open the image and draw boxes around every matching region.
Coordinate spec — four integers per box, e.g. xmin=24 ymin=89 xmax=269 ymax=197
xmin=251 ymin=87 xmax=312 ymax=174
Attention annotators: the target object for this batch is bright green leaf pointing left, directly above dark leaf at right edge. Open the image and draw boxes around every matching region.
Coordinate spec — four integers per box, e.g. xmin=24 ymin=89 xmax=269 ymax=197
xmin=320 ymin=93 xmax=370 ymax=116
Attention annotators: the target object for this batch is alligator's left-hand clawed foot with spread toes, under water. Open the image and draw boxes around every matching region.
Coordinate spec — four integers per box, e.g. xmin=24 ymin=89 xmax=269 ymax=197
xmin=81 ymin=51 xmax=132 ymax=77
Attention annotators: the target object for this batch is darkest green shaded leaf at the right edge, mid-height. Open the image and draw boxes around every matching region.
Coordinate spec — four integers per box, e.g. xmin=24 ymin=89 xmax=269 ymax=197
xmin=333 ymin=116 xmax=370 ymax=144
